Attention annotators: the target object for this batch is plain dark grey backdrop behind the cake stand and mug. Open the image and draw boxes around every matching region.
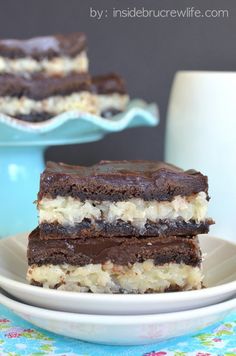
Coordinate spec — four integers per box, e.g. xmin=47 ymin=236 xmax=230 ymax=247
xmin=0 ymin=0 xmax=236 ymax=164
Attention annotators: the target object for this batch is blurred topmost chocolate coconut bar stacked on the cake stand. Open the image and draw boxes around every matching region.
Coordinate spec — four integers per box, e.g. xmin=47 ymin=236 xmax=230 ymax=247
xmin=0 ymin=32 xmax=88 ymax=76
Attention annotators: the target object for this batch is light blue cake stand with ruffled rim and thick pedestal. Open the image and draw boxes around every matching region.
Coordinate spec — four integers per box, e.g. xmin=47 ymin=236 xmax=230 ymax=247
xmin=0 ymin=100 xmax=159 ymax=237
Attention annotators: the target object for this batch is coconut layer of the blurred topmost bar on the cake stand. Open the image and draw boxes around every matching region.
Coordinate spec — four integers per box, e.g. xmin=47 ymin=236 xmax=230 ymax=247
xmin=0 ymin=52 xmax=88 ymax=76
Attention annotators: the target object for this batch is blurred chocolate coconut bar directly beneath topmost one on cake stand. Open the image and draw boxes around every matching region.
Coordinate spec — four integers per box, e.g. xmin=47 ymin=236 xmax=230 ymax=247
xmin=0 ymin=73 xmax=98 ymax=122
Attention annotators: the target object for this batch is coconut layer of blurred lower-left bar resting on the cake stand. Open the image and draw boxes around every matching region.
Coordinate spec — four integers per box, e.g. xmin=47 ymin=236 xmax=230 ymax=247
xmin=0 ymin=91 xmax=98 ymax=116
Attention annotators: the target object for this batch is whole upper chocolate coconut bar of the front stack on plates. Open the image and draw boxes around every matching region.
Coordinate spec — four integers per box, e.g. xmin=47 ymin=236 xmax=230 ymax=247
xmin=38 ymin=161 xmax=212 ymax=239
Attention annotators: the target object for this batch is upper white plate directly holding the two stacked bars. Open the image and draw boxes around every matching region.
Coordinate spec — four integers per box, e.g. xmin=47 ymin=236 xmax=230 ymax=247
xmin=0 ymin=234 xmax=236 ymax=315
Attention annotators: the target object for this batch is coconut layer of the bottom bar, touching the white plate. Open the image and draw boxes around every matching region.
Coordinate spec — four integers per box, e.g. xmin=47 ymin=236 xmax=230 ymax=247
xmin=27 ymin=260 xmax=203 ymax=293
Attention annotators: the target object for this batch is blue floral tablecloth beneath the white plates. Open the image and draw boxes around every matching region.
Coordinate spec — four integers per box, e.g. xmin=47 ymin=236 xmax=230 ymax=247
xmin=0 ymin=306 xmax=236 ymax=356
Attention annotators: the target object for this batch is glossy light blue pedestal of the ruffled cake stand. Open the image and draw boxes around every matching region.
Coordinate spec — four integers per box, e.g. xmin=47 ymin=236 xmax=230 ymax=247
xmin=0 ymin=146 xmax=46 ymax=236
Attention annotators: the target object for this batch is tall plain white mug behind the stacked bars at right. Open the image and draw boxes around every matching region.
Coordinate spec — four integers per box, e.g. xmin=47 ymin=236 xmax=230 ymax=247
xmin=165 ymin=71 xmax=236 ymax=242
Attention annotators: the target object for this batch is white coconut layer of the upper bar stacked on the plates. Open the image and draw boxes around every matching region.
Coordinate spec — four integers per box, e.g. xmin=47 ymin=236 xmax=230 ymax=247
xmin=38 ymin=192 xmax=208 ymax=228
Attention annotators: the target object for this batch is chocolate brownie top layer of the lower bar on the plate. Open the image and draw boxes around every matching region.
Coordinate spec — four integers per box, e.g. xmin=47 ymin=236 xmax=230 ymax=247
xmin=28 ymin=228 xmax=201 ymax=266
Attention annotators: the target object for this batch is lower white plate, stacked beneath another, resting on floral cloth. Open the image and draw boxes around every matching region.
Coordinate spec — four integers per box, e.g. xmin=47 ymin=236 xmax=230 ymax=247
xmin=0 ymin=293 xmax=236 ymax=345
